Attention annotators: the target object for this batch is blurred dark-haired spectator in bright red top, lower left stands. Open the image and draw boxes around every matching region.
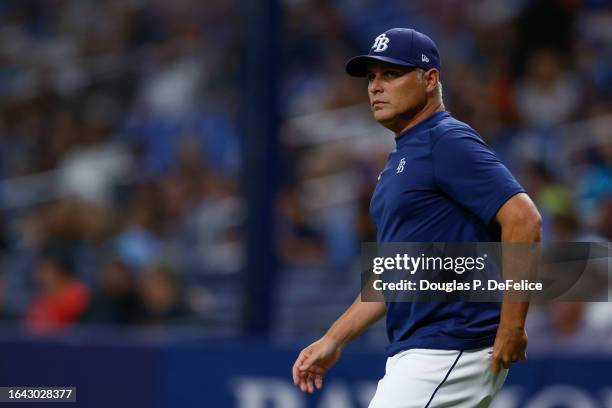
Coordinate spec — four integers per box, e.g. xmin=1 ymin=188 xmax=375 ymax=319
xmin=25 ymin=247 xmax=90 ymax=333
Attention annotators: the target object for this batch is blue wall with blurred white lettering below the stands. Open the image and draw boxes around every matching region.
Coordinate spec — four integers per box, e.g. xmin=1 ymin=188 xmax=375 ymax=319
xmin=0 ymin=337 xmax=612 ymax=408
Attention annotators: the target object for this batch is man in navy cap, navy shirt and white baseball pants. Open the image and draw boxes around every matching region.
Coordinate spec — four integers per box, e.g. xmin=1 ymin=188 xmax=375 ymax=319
xmin=293 ymin=28 xmax=541 ymax=408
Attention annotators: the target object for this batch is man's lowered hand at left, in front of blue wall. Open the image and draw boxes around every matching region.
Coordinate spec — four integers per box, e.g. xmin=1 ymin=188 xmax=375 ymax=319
xmin=293 ymin=336 xmax=342 ymax=393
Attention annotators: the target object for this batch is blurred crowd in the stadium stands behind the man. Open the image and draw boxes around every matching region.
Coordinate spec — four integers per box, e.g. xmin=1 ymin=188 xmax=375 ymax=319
xmin=0 ymin=0 xmax=612 ymax=345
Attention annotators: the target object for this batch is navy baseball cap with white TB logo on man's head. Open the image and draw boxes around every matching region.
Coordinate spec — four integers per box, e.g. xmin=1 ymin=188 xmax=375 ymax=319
xmin=346 ymin=28 xmax=440 ymax=77
